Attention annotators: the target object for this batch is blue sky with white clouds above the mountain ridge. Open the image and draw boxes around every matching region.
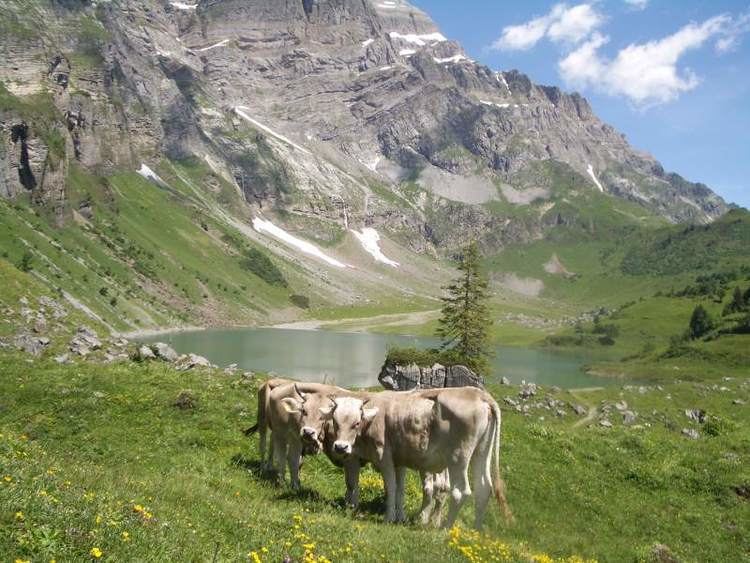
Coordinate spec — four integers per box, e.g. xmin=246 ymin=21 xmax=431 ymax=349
xmin=412 ymin=0 xmax=750 ymax=208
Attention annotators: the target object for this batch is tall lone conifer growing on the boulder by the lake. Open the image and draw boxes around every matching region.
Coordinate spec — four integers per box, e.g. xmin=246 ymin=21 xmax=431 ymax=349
xmin=437 ymin=243 xmax=492 ymax=375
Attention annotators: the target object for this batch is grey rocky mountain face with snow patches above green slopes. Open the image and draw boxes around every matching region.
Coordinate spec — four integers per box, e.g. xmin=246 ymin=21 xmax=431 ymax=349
xmin=0 ymin=0 xmax=727 ymax=330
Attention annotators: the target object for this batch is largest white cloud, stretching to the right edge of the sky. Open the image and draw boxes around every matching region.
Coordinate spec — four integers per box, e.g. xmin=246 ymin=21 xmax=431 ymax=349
xmin=558 ymin=14 xmax=750 ymax=107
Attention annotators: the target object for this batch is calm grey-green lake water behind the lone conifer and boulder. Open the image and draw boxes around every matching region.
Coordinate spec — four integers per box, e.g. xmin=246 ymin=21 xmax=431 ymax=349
xmin=144 ymin=328 xmax=621 ymax=388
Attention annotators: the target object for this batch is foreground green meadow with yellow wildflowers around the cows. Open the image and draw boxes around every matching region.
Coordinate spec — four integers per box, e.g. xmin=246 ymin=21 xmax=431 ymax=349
xmin=0 ymin=353 xmax=750 ymax=563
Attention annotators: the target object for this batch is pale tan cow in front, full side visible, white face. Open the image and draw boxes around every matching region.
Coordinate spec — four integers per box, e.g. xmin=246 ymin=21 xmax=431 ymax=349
xmin=321 ymin=387 xmax=512 ymax=529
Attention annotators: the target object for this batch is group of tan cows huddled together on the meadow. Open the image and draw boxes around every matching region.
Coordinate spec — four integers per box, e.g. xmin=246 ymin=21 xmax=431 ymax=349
xmin=245 ymin=379 xmax=512 ymax=529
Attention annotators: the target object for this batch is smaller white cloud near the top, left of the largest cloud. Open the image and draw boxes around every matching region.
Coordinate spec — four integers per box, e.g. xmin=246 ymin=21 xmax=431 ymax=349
xmin=491 ymin=3 xmax=604 ymax=51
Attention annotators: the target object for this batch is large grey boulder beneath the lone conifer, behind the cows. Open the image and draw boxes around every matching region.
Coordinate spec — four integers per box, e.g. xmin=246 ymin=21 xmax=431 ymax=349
xmin=378 ymin=362 xmax=484 ymax=391
